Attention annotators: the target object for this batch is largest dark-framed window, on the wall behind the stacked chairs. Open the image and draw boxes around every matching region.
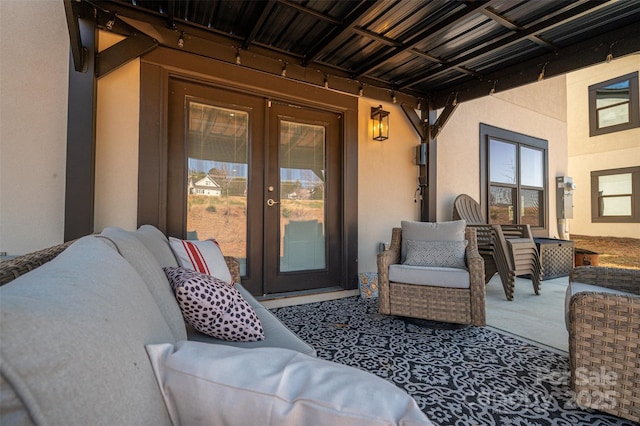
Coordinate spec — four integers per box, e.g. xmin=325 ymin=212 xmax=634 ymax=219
xmin=480 ymin=124 xmax=549 ymax=228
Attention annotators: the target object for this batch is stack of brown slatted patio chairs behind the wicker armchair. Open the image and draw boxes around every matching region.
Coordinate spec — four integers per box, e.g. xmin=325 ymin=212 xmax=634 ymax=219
xmin=453 ymin=194 xmax=542 ymax=300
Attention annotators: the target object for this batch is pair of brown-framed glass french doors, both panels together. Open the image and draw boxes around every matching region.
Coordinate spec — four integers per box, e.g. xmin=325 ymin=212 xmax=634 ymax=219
xmin=167 ymin=79 xmax=342 ymax=294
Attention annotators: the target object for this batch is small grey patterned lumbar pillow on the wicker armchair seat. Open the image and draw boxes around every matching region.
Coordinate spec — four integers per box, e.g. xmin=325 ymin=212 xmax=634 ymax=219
xmin=404 ymin=240 xmax=467 ymax=269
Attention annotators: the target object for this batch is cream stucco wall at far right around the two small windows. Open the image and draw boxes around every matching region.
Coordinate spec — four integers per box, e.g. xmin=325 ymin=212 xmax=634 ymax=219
xmin=567 ymin=54 xmax=640 ymax=238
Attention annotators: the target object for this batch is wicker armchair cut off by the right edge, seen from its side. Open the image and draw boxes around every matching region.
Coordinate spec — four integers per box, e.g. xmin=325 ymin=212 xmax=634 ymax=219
xmin=567 ymin=266 xmax=640 ymax=422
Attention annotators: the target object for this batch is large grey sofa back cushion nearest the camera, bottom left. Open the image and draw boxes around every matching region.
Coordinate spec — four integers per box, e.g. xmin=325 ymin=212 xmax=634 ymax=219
xmin=0 ymin=236 xmax=174 ymax=425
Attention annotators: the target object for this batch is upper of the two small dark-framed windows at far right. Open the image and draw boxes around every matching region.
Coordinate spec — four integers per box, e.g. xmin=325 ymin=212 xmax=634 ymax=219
xmin=589 ymin=72 xmax=640 ymax=136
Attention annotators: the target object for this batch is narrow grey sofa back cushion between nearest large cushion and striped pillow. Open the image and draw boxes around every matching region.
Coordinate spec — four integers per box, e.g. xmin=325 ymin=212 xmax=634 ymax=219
xmin=100 ymin=227 xmax=187 ymax=340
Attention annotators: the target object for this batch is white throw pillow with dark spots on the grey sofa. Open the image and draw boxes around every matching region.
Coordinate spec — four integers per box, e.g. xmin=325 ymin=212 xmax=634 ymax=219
xmin=164 ymin=267 xmax=264 ymax=342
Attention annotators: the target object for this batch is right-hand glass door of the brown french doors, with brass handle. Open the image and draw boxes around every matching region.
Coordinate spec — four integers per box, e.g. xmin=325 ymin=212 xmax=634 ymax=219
xmin=264 ymin=102 xmax=342 ymax=293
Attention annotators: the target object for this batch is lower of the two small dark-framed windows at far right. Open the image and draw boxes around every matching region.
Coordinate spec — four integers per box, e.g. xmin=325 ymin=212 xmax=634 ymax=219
xmin=591 ymin=167 xmax=640 ymax=222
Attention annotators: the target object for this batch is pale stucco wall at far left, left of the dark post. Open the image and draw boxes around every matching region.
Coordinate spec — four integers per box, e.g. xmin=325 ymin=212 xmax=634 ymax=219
xmin=0 ymin=0 xmax=69 ymax=254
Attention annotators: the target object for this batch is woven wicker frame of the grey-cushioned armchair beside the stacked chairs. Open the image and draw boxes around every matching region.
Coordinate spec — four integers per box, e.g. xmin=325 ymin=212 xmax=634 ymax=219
xmin=378 ymin=228 xmax=486 ymax=326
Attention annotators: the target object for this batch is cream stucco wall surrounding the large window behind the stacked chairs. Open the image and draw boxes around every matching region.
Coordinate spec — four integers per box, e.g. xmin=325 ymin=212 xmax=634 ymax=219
xmin=437 ymin=76 xmax=568 ymax=237
